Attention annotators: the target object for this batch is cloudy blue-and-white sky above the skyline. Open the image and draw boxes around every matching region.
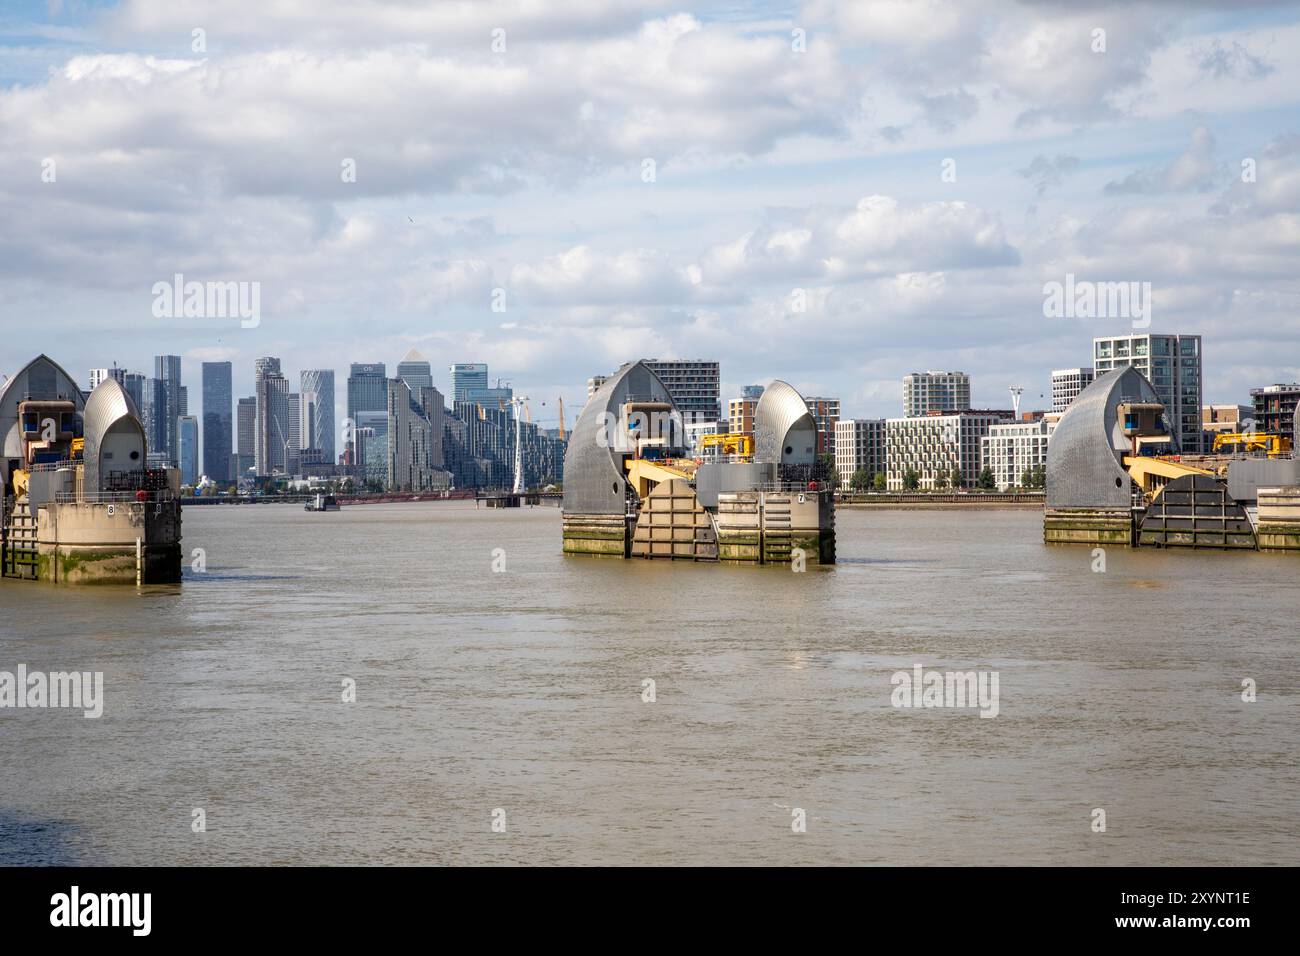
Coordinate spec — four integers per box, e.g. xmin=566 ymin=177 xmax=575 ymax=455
xmin=0 ymin=0 xmax=1300 ymax=437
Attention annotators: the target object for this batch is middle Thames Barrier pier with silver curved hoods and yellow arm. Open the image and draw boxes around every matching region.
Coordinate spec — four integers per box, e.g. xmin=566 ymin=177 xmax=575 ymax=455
xmin=563 ymin=362 xmax=835 ymax=564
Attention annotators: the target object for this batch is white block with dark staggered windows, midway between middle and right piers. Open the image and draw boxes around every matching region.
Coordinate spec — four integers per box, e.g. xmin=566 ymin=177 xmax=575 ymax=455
xmin=885 ymin=411 xmax=1010 ymax=492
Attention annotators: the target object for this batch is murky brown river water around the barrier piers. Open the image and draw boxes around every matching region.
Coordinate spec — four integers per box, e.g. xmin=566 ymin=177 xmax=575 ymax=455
xmin=0 ymin=502 xmax=1300 ymax=865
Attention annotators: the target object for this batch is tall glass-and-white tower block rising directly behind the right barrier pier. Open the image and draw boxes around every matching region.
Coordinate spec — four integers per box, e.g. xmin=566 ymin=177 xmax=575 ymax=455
xmin=1092 ymin=334 xmax=1203 ymax=455
